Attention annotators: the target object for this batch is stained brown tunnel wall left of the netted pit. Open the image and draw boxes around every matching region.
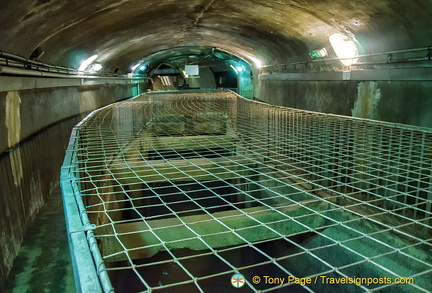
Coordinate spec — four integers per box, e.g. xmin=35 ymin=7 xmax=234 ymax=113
xmin=0 ymin=77 xmax=145 ymax=291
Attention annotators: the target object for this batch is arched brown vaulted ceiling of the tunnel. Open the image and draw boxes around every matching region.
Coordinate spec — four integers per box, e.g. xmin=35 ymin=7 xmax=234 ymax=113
xmin=0 ymin=0 xmax=432 ymax=70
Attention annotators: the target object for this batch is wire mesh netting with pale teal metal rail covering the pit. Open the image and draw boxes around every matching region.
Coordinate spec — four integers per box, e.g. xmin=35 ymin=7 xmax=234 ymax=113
xmin=62 ymin=91 xmax=432 ymax=292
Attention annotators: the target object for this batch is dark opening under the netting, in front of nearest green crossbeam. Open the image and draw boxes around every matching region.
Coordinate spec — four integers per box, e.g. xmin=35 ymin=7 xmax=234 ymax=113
xmin=110 ymin=232 xmax=315 ymax=293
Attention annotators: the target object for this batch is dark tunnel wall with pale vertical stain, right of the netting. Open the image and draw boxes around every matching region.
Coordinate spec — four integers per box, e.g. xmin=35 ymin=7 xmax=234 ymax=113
xmin=256 ymin=73 xmax=432 ymax=127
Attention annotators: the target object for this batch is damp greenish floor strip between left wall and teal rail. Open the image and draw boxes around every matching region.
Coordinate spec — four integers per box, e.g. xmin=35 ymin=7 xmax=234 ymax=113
xmin=5 ymin=187 xmax=75 ymax=293
